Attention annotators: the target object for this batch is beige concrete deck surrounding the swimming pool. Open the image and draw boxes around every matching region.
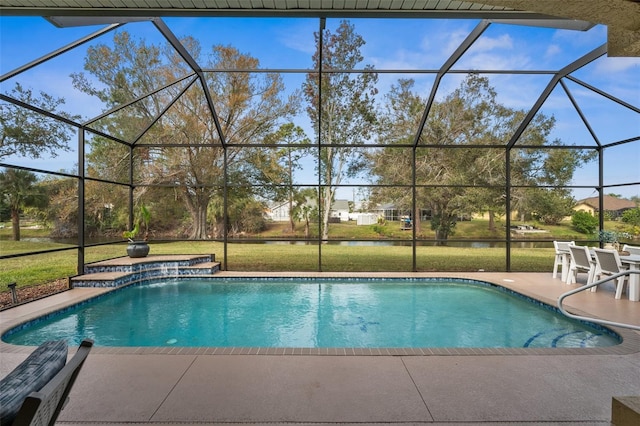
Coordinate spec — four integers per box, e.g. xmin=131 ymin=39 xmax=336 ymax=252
xmin=0 ymin=272 xmax=640 ymax=426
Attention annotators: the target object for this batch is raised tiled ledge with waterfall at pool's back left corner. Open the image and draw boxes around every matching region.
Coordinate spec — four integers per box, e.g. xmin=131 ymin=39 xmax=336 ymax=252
xmin=71 ymin=255 xmax=220 ymax=287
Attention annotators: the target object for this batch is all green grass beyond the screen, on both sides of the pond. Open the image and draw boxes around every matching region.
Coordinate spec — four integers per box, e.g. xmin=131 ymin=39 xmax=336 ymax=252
xmin=0 ymin=219 xmax=632 ymax=291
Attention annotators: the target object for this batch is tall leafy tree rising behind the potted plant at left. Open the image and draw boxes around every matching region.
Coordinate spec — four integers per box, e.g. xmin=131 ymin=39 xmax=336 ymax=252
xmin=71 ymin=31 xmax=181 ymax=235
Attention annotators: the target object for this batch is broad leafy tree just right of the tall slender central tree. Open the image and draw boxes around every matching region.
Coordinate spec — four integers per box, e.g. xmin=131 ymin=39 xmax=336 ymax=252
xmin=373 ymin=74 xmax=505 ymax=244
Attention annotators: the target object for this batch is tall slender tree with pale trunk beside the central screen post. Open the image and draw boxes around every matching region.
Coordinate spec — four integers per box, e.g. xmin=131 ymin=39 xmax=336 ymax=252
xmin=303 ymin=21 xmax=378 ymax=240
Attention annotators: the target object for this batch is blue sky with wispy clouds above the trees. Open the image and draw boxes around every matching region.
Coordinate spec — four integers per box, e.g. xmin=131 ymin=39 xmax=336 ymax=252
xmin=0 ymin=16 xmax=640 ymax=198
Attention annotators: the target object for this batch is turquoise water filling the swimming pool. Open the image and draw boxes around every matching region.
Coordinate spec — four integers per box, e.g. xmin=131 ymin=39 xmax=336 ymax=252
xmin=3 ymin=279 xmax=620 ymax=348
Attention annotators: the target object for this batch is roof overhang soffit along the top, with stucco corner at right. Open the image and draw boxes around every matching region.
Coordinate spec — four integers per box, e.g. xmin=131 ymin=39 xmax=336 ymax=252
xmin=0 ymin=0 xmax=640 ymax=56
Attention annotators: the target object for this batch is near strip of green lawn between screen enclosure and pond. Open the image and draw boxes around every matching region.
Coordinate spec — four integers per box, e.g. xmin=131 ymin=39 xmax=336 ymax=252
xmin=0 ymin=241 xmax=553 ymax=290
